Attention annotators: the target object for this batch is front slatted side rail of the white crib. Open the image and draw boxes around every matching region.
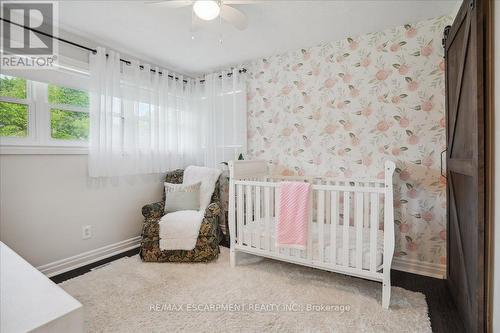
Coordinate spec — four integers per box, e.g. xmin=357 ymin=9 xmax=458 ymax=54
xmin=234 ymin=180 xmax=385 ymax=272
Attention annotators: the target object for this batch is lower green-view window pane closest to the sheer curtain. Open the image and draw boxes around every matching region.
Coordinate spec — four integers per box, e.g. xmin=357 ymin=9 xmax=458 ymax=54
xmin=50 ymin=109 xmax=89 ymax=140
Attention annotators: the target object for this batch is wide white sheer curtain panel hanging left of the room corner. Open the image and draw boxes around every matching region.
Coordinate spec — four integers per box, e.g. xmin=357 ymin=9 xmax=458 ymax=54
xmin=89 ymin=48 xmax=204 ymax=177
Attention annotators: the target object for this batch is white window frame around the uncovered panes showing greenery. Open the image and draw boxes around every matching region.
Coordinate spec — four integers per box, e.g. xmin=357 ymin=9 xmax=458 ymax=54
xmin=0 ymin=71 xmax=90 ymax=155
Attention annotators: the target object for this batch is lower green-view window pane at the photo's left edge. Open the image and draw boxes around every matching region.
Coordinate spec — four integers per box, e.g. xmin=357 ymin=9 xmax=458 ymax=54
xmin=0 ymin=102 xmax=29 ymax=137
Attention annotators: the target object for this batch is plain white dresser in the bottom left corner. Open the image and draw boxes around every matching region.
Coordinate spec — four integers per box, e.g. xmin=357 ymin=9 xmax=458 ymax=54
xmin=0 ymin=242 xmax=83 ymax=333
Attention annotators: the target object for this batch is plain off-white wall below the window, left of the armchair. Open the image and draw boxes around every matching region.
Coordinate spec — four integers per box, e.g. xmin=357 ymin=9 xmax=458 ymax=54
xmin=0 ymin=155 xmax=162 ymax=266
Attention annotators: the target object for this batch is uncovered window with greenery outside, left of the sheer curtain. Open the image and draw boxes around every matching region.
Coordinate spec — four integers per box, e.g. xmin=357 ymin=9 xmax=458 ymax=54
xmin=0 ymin=74 xmax=89 ymax=149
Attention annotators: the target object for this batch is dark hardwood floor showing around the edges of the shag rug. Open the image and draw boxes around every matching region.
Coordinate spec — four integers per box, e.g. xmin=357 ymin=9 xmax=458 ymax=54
xmin=51 ymin=248 xmax=465 ymax=333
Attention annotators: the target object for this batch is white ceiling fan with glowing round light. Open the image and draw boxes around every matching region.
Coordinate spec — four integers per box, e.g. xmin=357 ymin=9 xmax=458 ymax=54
xmin=146 ymin=0 xmax=254 ymax=31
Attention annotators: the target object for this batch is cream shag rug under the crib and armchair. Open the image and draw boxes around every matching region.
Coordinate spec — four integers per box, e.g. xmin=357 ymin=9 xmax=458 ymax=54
xmin=60 ymin=248 xmax=432 ymax=333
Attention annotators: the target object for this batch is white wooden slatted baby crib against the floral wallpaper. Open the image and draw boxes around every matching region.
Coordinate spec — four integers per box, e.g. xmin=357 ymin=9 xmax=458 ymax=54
xmin=229 ymin=161 xmax=395 ymax=309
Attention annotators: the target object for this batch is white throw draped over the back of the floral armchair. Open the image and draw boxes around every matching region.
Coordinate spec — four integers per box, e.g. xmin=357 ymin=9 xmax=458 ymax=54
xmin=182 ymin=166 xmax=221 ymax=210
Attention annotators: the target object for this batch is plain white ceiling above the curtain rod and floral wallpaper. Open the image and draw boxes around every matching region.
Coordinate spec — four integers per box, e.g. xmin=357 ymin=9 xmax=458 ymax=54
xmin=59 ymin=0 xmax=457 ymax=75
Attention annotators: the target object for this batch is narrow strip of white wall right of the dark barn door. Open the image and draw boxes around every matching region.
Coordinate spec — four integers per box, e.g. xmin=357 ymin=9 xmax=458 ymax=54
xmin=493 ymin=1 xmax=500 ymax=332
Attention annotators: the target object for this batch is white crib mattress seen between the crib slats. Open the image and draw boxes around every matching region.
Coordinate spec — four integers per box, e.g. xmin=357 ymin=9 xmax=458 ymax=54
xmin=243 ymin=218 xmax=384 ymax=269
